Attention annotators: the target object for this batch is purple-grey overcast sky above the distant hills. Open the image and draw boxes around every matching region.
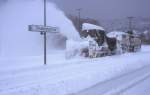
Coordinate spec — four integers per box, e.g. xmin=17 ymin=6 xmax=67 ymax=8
xmin=50 ymin=0 xmax=150 ymax=19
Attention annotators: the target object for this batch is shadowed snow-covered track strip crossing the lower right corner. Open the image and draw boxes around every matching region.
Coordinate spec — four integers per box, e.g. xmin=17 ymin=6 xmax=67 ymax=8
xmin=72 ymin=65 xmax=150 ymax=95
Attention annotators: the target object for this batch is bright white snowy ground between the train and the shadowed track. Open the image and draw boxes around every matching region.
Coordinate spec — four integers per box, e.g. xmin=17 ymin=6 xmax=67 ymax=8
xmin=0 ymin=46 xmax=150 ymax=95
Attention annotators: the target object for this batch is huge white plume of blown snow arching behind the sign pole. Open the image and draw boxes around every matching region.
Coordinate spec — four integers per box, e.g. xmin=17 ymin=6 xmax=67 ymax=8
xmin=0 ymin=0 xmax=79 ymax=57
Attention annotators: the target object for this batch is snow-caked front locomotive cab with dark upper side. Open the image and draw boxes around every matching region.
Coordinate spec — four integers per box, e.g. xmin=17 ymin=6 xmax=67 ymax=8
xmin=82 ymin=23 xmax=108 ymax=57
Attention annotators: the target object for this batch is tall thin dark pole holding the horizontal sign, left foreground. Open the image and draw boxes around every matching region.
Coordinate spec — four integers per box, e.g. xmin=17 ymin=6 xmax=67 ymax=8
xmin=44 ymin=0 xmax=47 ymax=65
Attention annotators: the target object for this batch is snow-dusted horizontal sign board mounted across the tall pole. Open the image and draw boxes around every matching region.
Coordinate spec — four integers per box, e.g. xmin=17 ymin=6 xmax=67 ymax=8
xmin=28 ymin=25 xmax=59 ymax=33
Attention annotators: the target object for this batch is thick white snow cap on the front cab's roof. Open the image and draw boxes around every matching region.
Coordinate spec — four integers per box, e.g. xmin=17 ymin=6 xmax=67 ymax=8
xmin=82 ymin=23 xmax=104 ymax=30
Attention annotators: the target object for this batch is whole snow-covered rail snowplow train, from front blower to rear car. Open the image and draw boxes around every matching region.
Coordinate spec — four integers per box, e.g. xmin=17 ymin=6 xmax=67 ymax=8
xmin=66 ymin=23 xmax=141 ymax=58
